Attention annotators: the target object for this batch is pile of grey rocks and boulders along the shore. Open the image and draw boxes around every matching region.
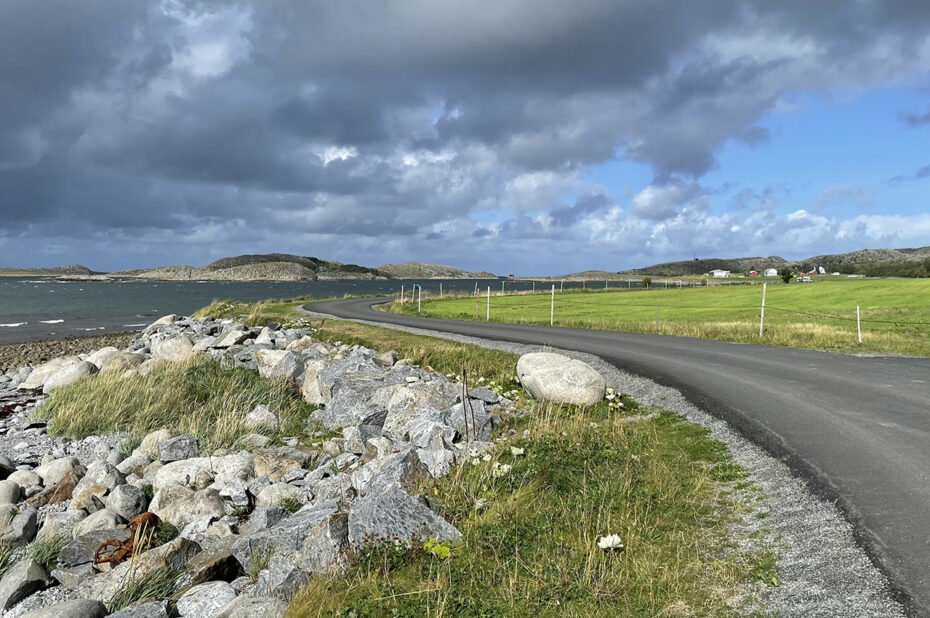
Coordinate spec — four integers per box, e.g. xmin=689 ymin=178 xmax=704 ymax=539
xmin=0 ymin=315 xmax=511 ymax=616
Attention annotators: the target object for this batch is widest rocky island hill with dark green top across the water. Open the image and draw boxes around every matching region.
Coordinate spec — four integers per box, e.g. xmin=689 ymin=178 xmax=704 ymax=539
xmin=110 ymin=253 xmax=389 ymax=281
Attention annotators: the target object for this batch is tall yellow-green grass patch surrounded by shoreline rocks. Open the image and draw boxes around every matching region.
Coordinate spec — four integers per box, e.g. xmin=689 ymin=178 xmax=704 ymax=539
xmin=35 ymin=356 xmax=314 ymax=452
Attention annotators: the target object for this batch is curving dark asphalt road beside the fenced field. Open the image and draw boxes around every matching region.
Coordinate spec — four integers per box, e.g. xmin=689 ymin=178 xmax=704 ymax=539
xmin=305 ymin=298 xmax=930 ymax=616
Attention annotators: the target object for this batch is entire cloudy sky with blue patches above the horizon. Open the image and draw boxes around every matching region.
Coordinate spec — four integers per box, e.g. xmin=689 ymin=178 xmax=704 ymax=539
xmin=0 ymin=0 xmax=930 ymax=275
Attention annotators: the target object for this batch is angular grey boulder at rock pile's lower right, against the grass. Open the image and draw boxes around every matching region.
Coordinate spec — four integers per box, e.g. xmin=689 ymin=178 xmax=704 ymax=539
xmin=349 ymin=487 xmax=462 ymax=547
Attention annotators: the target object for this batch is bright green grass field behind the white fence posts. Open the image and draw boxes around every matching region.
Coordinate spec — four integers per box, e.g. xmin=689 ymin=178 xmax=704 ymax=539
xmin=385 ymin=277 xmax=930 ymax=356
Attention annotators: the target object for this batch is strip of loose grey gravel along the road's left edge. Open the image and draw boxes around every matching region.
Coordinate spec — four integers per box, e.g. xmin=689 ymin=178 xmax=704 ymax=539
xmin=307 ymin=312 xmax=913 ymax=618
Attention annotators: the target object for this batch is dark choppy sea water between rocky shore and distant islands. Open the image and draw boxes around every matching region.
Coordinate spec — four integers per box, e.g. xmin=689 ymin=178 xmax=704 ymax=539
xmin=0 ymin=277 xmax=596 ymax=343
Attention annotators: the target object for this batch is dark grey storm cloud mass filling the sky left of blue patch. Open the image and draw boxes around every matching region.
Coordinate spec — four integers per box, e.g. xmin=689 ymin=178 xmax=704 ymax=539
xmin=0 ymin=0 xmax=928 ymax=270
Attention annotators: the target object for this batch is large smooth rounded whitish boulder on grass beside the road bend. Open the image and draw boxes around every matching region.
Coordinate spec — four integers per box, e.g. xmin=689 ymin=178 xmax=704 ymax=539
xmin=517 ymin=352 xmax=607 ymax=406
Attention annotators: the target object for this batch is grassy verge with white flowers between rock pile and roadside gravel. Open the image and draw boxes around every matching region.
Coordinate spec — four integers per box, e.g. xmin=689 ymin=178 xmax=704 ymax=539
xmin=286 ymin=399 xmax=777 ymax=617
